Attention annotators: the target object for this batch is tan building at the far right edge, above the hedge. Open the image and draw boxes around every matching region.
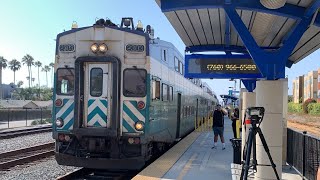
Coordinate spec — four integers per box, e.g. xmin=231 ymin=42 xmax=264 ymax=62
xmin=303 ymin=71 xmax=318 ymax=101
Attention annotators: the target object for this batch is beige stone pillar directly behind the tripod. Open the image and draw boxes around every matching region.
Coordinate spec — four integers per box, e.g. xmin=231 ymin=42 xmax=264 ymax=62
xmin=255 ymin=80 xmax=288 ymax=179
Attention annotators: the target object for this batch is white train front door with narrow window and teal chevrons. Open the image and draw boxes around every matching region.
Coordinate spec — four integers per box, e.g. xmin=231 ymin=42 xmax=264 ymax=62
xmin=83 ymin=63 xmax=111 ymax=127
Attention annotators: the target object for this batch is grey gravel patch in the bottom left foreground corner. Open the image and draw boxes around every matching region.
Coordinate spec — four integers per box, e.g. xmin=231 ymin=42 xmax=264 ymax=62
xmin=0 ymin=157 xmax=79 ymax=180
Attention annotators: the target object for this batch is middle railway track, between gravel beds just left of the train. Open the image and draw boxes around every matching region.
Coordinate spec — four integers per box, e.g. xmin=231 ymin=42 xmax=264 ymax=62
xmin=0 ymin=142 xmax=54 ymax=171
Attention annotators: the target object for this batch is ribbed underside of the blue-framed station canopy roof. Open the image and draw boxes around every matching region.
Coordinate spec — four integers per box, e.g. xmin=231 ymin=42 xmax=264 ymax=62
xmin=156 ymin=0 xmax=320 ymax=63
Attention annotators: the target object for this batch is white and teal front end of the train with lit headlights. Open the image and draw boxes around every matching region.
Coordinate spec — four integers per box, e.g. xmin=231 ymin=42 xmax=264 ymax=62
xmin=53 ymin=17 xmax=148 ymax=169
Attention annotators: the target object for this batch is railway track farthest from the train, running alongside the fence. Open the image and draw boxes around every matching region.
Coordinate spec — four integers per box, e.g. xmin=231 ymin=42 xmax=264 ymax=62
xmin=0 ymin=125 xmax=52 ymax=139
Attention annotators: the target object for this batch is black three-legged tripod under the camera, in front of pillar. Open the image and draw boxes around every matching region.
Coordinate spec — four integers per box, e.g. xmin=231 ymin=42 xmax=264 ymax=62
xmin=240 ymin=117 xmax=280 ymax=180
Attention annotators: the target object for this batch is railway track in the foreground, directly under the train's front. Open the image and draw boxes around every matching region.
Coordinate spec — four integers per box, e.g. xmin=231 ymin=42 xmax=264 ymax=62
xmin=57 ymin=168 xmax=138 ymax=180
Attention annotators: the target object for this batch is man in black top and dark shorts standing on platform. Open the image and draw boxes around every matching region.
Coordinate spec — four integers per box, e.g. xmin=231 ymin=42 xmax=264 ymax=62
xmin=211 ymin=104 xmax=227 ymax=150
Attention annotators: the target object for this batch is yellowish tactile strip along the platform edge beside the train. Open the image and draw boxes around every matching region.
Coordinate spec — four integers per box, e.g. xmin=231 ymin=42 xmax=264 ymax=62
xmin=132 ymin=132 xmax=201 ymax=180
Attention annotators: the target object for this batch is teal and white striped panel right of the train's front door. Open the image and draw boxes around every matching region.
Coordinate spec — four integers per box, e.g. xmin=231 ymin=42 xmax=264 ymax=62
xmin=122 ymin=101 xmax=146 ymax=133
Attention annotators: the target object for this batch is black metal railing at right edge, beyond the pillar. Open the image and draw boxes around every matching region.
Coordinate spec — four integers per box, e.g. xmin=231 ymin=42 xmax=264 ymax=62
xmin=287 ymin=128 xmax=320 ymax=180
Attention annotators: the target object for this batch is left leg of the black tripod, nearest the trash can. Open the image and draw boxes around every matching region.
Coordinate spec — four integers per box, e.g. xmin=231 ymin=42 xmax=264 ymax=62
xmin=240 ymin=128 xmax=255 ymax=180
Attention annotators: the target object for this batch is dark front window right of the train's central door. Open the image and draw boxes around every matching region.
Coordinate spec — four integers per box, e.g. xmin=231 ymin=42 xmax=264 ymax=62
xmin=123 ymin=69 xmax=147 ymax=97
